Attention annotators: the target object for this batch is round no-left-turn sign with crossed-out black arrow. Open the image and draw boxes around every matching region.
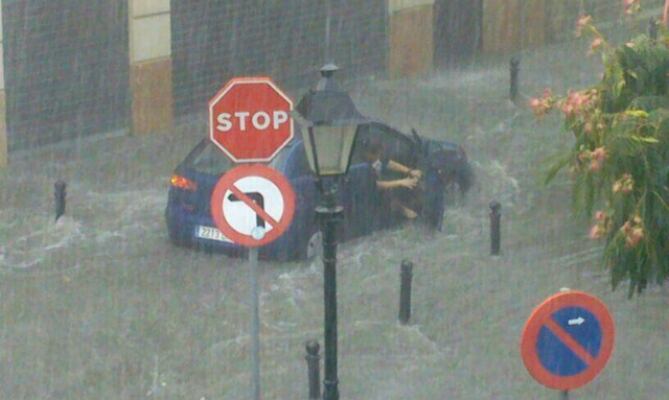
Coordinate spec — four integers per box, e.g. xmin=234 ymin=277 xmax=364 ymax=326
xmin=211 ymin=165 xmax=295 ymax=247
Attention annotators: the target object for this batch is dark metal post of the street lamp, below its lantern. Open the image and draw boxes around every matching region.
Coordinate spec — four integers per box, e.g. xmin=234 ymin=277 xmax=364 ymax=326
xmin=316 ymin=189 xmax=343 ymax=400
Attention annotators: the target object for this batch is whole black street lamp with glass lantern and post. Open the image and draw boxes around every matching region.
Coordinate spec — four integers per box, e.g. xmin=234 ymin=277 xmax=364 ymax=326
xmin=297 ymin=64 xmax=365 ymax=400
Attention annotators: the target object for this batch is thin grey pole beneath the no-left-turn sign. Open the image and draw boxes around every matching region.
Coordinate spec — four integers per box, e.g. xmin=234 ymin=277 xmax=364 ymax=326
xmin=249 ymin=227 xmax=265 ymax=400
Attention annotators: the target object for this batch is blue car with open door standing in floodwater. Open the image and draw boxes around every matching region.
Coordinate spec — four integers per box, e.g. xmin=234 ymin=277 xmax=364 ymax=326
xmin=165 ymin=121 xmax=472 ymax=260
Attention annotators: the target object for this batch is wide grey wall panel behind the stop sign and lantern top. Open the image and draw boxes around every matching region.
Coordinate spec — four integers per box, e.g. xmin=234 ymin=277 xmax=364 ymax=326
xmin=172 ymin=0 xmax=388 ymax=115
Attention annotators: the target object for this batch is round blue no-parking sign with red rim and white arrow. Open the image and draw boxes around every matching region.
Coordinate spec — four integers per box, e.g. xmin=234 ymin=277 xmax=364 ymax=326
xmin=520 ymin=291 xmax=615 ymax=391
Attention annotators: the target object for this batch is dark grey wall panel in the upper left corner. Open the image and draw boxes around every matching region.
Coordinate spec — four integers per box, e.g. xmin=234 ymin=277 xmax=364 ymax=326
xmin=2 ymin=0 xmax=129 ymax=151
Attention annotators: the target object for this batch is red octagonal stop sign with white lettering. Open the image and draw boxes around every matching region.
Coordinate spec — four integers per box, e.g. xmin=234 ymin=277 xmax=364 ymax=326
xmin=209 ymin=77 xmax=293 ymax=162
